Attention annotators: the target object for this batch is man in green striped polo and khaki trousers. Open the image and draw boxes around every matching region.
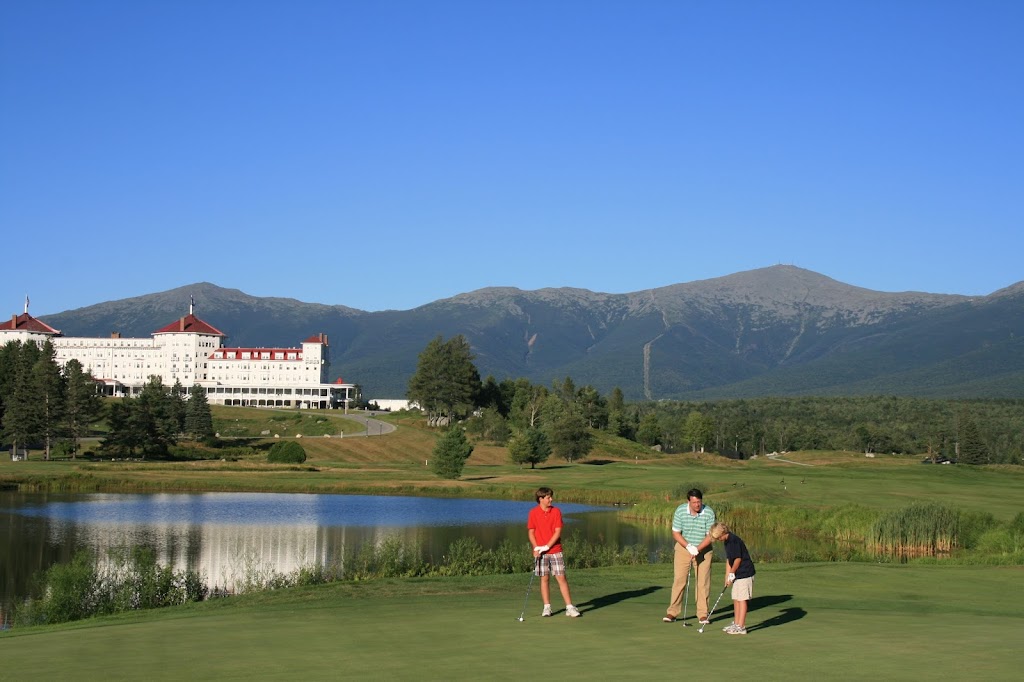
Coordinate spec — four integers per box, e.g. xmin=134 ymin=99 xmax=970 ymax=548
xmin=662 ymin=487 xmax=715 ymax=623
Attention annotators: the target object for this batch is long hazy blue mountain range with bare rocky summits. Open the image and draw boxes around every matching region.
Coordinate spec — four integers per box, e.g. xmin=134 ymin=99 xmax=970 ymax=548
xmin=29 ymin=265 xmax=1024 ymax=400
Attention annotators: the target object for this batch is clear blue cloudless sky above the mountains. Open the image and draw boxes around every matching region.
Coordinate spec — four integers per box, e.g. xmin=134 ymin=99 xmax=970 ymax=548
xmin=0 ymin=0 xmax=1024 ymax=315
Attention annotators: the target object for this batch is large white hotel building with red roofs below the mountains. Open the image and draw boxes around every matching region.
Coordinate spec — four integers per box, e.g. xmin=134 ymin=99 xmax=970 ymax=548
xmin=0 ymin=303 xmax=359 ymax=409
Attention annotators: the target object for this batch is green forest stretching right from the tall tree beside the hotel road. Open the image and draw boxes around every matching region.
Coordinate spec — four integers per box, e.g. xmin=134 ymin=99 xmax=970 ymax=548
xmin=408 ymin=336 xmax=1024 ymax=466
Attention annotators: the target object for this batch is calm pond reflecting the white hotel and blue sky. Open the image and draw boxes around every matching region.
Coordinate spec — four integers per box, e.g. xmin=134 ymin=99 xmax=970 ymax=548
xmin=0 ymin=485 xmax=671 ymax=610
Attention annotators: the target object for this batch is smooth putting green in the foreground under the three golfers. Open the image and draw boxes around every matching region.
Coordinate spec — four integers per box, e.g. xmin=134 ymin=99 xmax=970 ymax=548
xmin=0 ymin=563 xmax=1024 ymax=680
